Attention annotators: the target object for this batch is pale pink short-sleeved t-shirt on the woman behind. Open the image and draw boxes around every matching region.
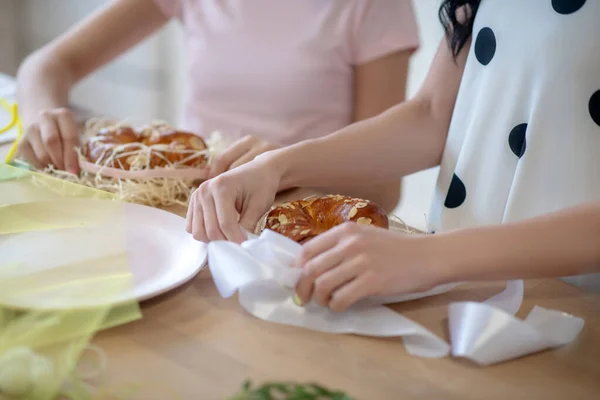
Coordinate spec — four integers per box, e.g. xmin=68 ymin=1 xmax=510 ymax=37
xmin=155 ymin=0 xmax=419 ymax=145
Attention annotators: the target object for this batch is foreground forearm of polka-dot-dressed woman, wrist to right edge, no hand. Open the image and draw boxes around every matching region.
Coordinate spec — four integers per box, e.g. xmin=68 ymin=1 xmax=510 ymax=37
xmin=432 ymin=203 xmax=600 ymax=282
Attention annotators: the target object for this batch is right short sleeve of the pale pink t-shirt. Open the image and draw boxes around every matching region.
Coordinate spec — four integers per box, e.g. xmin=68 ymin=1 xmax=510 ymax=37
xmin=350 ymin=0 xmax=419 ymax=65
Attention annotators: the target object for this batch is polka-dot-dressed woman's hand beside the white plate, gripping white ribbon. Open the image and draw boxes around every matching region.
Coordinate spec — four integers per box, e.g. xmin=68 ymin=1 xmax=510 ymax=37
xmin=186 ymin=157 xmax=281 ymax=243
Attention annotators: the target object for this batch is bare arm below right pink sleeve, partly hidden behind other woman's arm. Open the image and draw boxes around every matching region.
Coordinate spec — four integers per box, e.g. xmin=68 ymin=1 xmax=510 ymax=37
xmin=326 ymin=50 xmax=412 ymax=211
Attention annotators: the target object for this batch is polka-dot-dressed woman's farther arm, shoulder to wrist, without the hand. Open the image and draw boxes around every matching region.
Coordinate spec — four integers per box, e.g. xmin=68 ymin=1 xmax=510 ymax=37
xmin=264 ymin=40 xmax=469 ymax=189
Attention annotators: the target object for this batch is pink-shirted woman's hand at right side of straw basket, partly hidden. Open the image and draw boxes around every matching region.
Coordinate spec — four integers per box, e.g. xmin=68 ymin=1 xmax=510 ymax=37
xmin=209 ymin=135 xmax=278 ymax=178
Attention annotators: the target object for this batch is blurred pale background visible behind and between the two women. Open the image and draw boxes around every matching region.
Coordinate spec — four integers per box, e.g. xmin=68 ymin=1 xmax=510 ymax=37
xmin=0 ymin=0 xmax=442 ymax=229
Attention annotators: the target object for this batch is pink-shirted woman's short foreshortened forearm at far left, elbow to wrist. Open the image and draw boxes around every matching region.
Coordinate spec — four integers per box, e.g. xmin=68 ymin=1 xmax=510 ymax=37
xmin=17 ymin=53 xmax=73 ymax=124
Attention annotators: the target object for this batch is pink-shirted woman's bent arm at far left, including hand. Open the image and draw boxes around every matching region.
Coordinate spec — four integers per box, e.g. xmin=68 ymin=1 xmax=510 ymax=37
xmin=17 ymin=0 xmax=167 ymax=168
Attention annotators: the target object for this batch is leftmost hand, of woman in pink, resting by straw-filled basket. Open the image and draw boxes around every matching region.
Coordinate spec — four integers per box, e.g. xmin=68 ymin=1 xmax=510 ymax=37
xmin=17 ymin=108 xmax=79 ymax=174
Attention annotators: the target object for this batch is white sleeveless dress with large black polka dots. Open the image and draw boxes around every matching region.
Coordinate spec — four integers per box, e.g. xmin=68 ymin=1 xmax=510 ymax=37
xmin=429 ymin=0 xmax=600 ymax=287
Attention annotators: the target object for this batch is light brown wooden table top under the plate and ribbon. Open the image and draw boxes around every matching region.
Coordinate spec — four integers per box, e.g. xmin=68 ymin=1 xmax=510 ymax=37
xmin=0 ymin=145 xmax=600 ymax=400
